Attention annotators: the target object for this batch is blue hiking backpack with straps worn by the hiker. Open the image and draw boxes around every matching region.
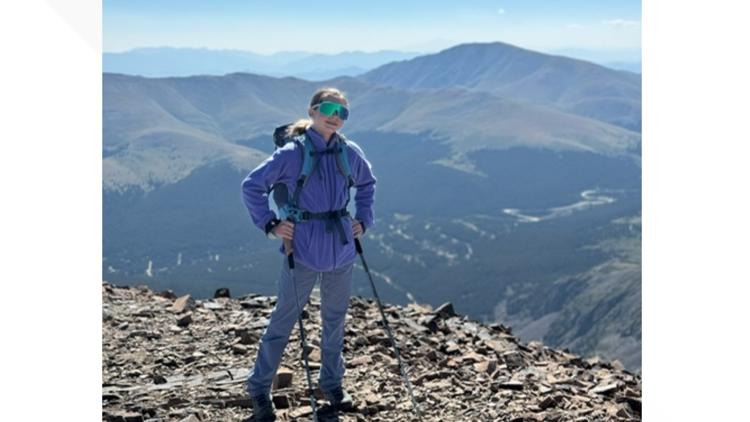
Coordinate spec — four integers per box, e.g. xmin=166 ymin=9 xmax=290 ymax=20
xmin=269 ymin=123 xmax=354 ymax=245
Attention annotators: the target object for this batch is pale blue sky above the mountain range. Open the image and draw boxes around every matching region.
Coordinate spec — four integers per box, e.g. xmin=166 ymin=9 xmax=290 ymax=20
xmin=103 ymin=0 xmax=641 ymax=54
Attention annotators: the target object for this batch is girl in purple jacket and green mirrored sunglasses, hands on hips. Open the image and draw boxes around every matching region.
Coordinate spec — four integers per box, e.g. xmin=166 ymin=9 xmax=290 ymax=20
xmin=242 ymin=88 xmax=375 ymax=420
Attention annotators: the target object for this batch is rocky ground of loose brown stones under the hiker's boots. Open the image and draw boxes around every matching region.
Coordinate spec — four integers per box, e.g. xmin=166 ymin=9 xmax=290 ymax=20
xmin=102 ymin=282 xmax=641 ymax=422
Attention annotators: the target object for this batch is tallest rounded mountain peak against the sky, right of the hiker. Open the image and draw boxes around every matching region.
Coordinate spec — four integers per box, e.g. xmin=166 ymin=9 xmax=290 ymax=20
xmin=359 ymin=41 xmax=641 ymax=132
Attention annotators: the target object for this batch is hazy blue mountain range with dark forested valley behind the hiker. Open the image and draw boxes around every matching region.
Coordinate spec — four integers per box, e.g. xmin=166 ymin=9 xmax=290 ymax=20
xmin=102 ymin=43 xmax=641 ymax=369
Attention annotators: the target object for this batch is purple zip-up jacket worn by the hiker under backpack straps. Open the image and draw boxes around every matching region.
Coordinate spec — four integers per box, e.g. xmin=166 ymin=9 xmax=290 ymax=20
xmin=242 ymin=127 xmax=376 ymax=271
